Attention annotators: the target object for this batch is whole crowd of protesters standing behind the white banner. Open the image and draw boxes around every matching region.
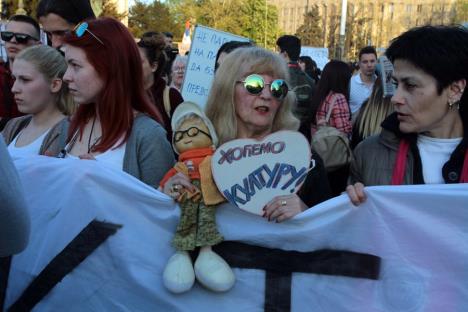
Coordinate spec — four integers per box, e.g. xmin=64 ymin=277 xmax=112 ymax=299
xmin=0 ymin=0 xmax=468 ymax=308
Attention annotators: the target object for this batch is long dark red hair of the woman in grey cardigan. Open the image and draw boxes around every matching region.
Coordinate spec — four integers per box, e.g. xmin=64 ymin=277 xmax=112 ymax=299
xmin=65 ymin=18 xmax=163 ymax=152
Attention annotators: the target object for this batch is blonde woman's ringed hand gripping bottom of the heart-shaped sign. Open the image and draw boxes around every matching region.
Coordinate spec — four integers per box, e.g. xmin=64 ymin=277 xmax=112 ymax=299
xmin=263 ymin=194 xmax=307 ymax=222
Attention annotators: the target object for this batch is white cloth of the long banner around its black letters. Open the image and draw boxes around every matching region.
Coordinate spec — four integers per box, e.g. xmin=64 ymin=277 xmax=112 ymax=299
xmin=6 ymin=156 xmax=468 ymax=312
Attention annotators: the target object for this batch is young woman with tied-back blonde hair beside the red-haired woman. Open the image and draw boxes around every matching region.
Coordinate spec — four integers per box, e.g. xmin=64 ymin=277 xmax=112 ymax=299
xmin=2 ymin=45 xmax=74 ymax=159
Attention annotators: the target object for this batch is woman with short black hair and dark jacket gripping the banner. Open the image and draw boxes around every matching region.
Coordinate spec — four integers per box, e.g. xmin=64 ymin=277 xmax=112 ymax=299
xmin=347 ymin=26 xmax=468 ymax=205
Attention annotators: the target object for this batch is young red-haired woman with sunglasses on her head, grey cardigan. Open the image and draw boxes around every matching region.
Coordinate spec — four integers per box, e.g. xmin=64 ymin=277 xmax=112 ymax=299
xmin=63 ymin=18 xmax=174 ymax=186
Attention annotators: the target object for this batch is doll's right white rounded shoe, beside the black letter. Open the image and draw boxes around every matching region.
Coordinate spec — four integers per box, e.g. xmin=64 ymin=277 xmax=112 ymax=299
xmin=195 ymin=248 xmax=236 ymax=292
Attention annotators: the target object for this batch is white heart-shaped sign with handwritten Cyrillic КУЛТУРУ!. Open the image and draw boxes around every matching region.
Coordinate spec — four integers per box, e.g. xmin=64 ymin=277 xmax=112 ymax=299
xmin=211 ymin=131 xmax=311 ymax=215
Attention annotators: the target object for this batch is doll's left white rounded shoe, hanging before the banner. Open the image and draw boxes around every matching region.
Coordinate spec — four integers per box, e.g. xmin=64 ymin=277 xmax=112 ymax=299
xmin=163 ymin=251 xmax=195 ymax=294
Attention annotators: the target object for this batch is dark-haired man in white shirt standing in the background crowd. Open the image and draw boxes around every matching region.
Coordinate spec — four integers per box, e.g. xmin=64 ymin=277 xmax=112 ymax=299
xmin=349 ymin=46 xmax=377 ymax=116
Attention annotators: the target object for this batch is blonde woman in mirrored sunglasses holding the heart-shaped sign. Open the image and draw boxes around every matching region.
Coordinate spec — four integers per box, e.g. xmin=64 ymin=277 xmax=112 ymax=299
xmin=168 ymin=47 xmax=331 ymax=222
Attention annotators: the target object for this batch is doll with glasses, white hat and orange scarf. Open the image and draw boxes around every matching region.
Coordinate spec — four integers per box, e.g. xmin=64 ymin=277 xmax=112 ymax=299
xmin=160 ymin=102 xmax=235 ymax=293
